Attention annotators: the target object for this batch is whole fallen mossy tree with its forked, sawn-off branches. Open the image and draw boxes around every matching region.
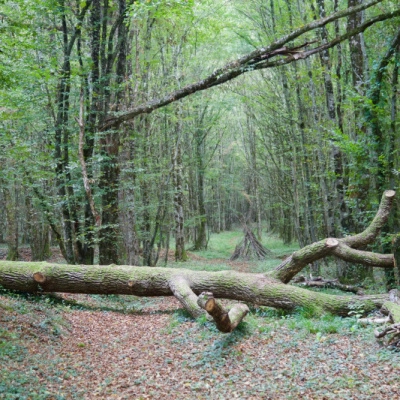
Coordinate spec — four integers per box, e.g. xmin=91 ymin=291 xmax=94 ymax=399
xmin=0 ymin=190 xmax=395 ymax=332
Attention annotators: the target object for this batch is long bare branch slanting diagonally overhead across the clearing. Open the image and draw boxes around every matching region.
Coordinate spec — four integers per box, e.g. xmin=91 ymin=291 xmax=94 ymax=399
xmin=101 ymin=0 xmax=389 ymax=131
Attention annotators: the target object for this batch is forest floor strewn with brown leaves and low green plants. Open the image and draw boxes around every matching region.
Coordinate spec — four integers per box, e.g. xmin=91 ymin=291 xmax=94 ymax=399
xmin=0 ymin=233 xmax=400 ymax=400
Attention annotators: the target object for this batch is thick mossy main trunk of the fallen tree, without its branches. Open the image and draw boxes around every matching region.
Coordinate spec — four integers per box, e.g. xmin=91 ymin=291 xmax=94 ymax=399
xmin=0 ymin=261 xmax=389 ymax=316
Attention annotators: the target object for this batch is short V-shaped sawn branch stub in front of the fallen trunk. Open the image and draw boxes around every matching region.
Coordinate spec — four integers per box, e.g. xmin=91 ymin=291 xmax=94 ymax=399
xmin=197 ymin=292 xmax=249 ymax=333
